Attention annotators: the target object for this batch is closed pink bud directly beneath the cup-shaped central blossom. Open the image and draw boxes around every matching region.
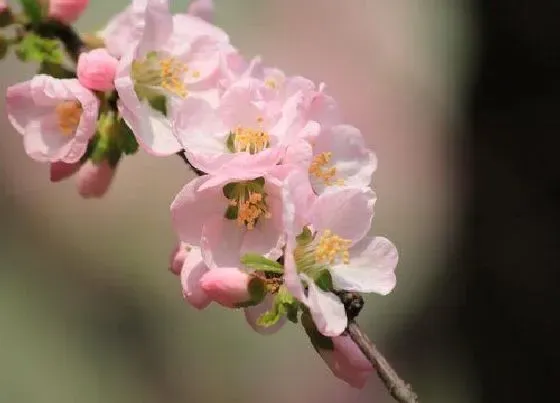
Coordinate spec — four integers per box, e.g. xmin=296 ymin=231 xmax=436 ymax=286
xmin=200 ymin=267 xmax=251 ymax=308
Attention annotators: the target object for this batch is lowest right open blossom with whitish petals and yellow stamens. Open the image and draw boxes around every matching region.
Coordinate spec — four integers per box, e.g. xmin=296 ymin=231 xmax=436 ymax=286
xmin=283 ymin=178 xmax=398 ymax=336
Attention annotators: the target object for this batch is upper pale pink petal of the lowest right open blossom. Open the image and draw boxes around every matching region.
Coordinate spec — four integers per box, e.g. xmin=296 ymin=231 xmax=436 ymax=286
xmin=311 ymin=188 xmax=376 ymax=243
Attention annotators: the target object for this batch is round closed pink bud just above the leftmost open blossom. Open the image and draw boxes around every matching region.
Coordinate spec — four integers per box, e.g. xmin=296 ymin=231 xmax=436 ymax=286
xmin=78 ymin=49 xmax=119 ymax=91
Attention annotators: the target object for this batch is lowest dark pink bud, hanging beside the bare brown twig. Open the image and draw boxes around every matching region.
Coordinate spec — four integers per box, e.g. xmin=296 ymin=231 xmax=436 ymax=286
xmin=318 ymin=336 xmax=374 ymax=389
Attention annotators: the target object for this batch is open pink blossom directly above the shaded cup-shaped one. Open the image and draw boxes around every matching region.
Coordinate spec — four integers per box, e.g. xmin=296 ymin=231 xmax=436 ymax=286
xmin=173 ymin=78 xmax=303 ymax=175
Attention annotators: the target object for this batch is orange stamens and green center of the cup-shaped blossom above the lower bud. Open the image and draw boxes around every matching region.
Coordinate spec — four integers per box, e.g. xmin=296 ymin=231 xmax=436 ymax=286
xmin=224 ymin=178 xmax=272 ymax=230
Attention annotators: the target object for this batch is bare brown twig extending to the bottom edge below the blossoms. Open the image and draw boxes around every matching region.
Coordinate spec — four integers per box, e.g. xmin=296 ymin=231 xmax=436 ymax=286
xmin=348 ymin=321 xmax=418 ymax=403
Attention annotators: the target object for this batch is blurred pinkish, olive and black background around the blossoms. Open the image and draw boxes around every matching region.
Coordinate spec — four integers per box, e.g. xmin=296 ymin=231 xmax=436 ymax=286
xmin=0 ymin=0 xmax=560 ymax=403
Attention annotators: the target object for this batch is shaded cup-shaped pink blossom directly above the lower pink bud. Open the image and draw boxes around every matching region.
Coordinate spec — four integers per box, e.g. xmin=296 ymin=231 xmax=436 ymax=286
xmin=171 ymin=168 xmax=312 ymax=267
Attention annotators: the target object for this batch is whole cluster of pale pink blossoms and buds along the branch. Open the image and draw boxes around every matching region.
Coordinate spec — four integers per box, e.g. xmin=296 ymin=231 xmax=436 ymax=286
xmin=0 ymin=0 xmax=398 ymax=387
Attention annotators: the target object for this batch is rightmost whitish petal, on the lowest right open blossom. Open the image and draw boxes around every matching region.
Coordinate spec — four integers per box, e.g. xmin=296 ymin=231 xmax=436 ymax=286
xmin=331 ymin=237 xmax=399 ymax=295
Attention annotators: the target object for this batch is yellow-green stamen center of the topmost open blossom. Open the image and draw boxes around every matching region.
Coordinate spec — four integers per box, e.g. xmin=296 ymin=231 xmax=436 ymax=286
xmin=131 ymin=52 xmax=190 ymax=98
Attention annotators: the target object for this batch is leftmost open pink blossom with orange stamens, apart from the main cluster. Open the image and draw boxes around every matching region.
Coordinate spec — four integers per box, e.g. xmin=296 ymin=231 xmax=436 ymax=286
xmin=6 ymin=75 xmax=99 ymax=163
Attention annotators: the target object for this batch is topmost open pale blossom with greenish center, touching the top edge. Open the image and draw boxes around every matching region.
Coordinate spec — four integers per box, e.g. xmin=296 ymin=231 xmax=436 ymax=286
xmin=115 ymin=0 xmax=241 ymax=156
